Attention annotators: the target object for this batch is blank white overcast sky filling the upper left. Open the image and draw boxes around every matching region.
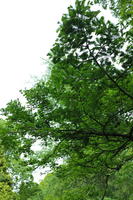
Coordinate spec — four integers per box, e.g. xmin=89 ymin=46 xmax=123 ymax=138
xmin=0 ymin=0 xmax=74 ymax=107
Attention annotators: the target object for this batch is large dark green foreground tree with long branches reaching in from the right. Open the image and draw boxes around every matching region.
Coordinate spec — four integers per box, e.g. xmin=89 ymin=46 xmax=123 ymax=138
xmin=3 ymin=0 xmax=133 ymax=199
